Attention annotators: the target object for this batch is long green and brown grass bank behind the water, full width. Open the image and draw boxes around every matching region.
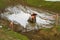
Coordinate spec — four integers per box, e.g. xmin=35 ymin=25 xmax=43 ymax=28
xmin=0 ymin=0 xmax=60 ymax=13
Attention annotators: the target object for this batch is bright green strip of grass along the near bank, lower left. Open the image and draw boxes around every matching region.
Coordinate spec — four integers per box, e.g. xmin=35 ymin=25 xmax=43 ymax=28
xmin=6 ymin=31 xmax=29 ymax=40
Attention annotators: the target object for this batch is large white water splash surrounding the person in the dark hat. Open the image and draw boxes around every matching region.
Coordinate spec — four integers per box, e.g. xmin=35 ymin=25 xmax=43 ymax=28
xmin=3 ymin=5 xmax=54 ymax=30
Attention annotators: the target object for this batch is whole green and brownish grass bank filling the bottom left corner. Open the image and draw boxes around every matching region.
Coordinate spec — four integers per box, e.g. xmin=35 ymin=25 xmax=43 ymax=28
xmin=0 ymin=27 xmax=29 ymax=40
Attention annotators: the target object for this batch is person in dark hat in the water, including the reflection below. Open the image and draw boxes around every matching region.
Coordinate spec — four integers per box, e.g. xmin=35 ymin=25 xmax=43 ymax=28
xmin=26 ymin=13 xmax=37 ymax=31
